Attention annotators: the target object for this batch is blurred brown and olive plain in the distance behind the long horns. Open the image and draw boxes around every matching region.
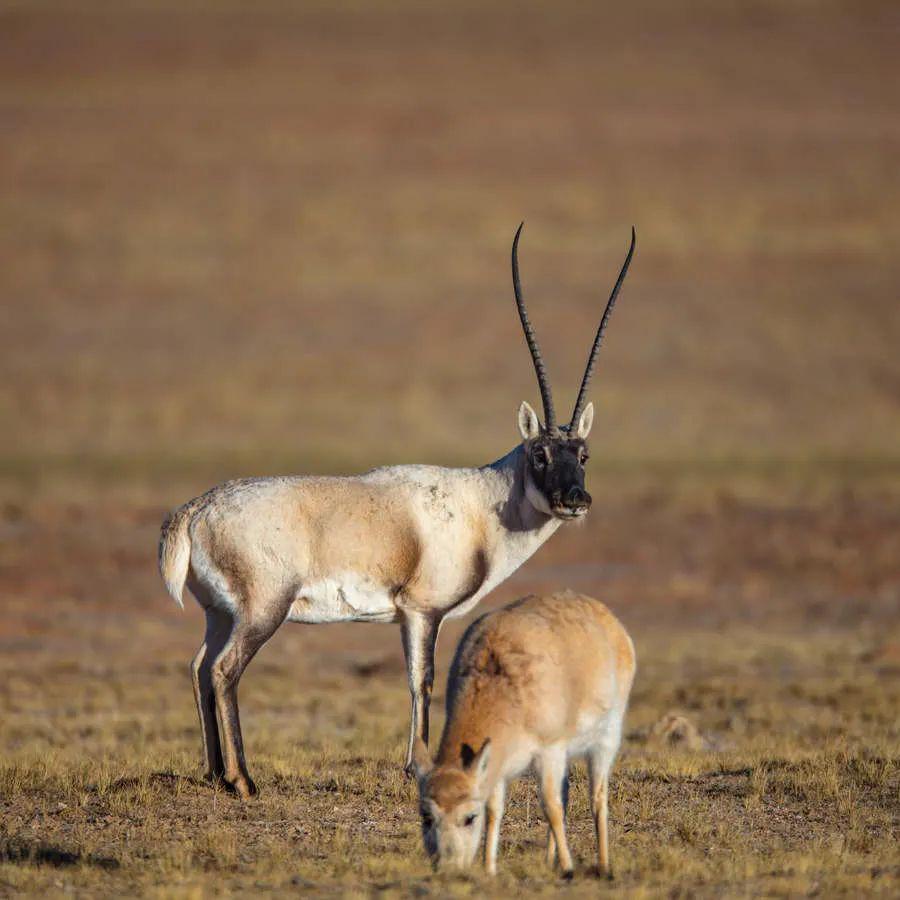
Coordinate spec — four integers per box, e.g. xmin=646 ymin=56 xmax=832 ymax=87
xmin=0 ymin=2 xmax=900 ymax=492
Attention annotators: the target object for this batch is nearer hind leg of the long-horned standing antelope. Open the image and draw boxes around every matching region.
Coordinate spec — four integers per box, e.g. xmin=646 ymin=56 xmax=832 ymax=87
xmin=212 ymin=604 xmax=287 ymax=799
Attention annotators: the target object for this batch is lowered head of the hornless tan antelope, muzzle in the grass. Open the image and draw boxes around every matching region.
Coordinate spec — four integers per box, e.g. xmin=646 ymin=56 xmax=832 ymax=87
xmin=413 ymin=740 xmax=491 ymax=869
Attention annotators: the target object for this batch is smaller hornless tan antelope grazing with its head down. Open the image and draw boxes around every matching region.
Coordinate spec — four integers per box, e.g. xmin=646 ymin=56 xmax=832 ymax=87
xmin=413 ymin=591 xmax=635 ymax=878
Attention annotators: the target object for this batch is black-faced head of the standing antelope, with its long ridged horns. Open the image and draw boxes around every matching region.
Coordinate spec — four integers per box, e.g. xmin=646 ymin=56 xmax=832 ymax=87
xmin=512 ymin=223 xmax=635 ymax=520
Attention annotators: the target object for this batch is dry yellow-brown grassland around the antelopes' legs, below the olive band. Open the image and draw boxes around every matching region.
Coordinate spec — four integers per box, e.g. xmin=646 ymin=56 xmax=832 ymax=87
xmin=0 ymin=486 xmax=900 ymax=896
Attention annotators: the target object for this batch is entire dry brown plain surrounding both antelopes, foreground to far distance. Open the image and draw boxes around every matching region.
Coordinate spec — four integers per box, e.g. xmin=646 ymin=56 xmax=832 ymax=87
xmin=0 ymin=0 xmax=900 ymax=897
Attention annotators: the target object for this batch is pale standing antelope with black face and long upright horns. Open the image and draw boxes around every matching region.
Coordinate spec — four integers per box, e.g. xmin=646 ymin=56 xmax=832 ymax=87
xmin=159 ymin=225 xmax=635 ymax=797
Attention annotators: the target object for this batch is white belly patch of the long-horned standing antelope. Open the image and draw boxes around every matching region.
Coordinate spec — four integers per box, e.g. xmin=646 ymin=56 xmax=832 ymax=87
xmin=287 ymin=572 xmax=398 ymax=625
